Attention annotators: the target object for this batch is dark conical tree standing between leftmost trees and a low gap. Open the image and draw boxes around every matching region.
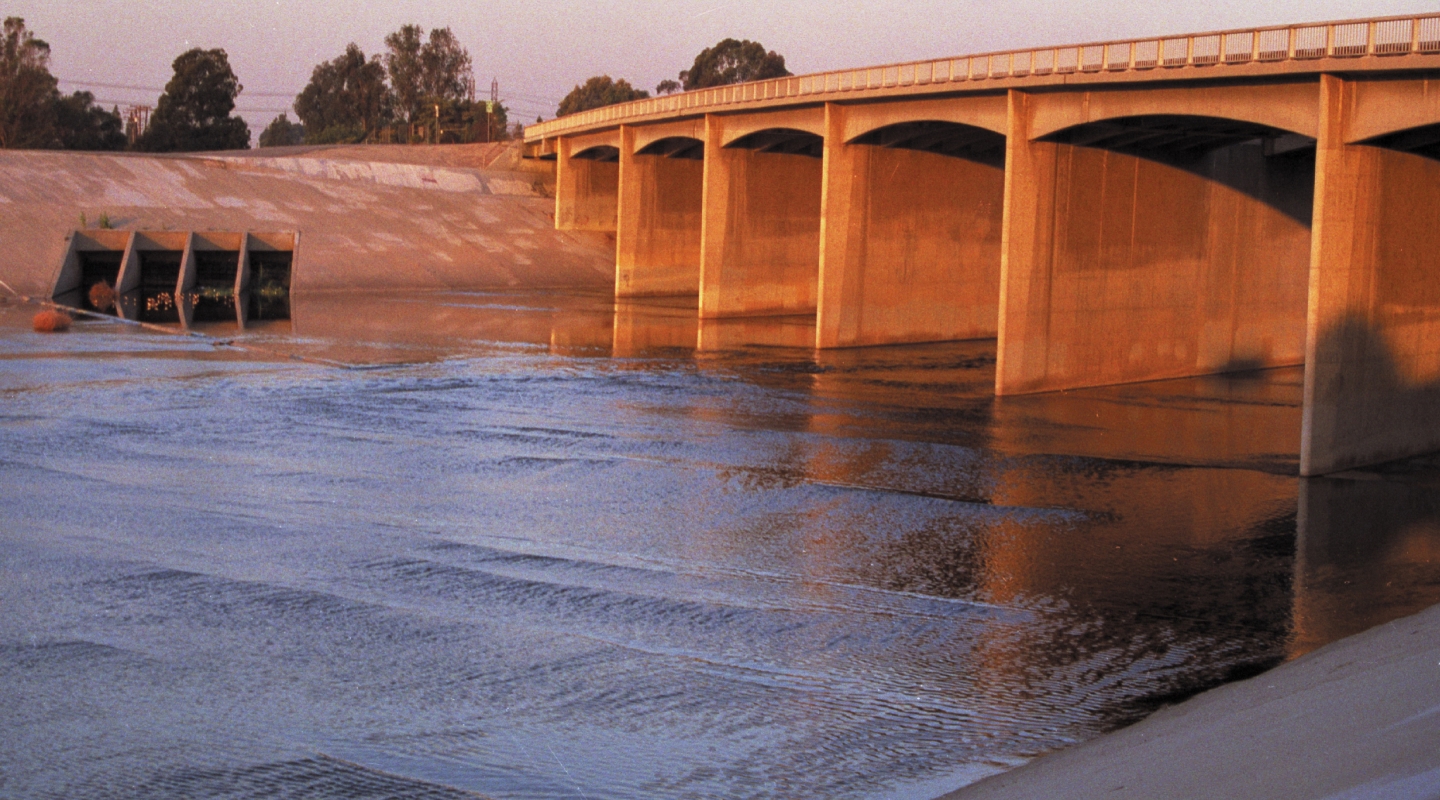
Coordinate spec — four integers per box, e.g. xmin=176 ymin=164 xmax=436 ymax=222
xmin=138 ymin=47 xmax=251 ymax=153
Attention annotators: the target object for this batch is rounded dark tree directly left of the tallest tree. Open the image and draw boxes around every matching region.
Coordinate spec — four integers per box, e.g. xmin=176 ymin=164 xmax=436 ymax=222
xmin=295 ymin=42 xmax=392 ymax=144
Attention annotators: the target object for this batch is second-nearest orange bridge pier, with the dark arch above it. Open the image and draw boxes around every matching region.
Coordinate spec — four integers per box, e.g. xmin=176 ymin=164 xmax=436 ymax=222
xmin=995 ymin=85 xmax=1315 ymax=394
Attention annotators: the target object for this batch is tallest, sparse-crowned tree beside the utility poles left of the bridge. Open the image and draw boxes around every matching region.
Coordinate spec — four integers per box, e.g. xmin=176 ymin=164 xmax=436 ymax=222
xmin=384 ymin=24 xmax=471 ymax=122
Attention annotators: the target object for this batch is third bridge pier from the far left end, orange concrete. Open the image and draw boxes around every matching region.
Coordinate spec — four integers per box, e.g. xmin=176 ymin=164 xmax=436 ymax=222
xmin=700 ymin=115 xmax=821 ymax=319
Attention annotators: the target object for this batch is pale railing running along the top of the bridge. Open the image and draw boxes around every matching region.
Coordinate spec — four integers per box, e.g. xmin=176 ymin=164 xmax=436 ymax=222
xmin=526 ymin=14 xmax=1440 ymax=140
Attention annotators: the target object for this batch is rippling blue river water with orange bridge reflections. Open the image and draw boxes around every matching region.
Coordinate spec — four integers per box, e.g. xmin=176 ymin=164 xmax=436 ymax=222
xmin=0 ymin=294 xmax=1440 ymax=800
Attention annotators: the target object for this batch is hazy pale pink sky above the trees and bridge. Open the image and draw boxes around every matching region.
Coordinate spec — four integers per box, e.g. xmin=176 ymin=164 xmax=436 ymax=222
xmin=14 ymin=0 xmax=1436 ymax=131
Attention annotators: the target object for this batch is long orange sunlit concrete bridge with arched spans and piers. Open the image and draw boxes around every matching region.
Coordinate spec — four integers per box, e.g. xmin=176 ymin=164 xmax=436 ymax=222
xmin=526 ymin=14 xmax=1440 ymax=475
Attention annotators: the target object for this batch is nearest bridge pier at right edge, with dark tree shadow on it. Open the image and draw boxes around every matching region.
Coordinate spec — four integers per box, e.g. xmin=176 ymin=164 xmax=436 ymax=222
xmin=1300 ymin=75 xmax=1440 ymax=475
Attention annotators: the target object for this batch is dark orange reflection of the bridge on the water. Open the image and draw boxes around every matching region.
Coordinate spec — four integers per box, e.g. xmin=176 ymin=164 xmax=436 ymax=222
xmin=272 ymin=294 xmax=1440 ymax=658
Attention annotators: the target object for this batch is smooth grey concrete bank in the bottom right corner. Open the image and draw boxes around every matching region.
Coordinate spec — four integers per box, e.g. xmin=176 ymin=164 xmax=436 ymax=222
xmin=940 ymin=606 xmax=1440 ymax=800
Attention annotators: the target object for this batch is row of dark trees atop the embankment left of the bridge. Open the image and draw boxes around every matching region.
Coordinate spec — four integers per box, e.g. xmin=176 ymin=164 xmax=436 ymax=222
xmin=0 ymin=17 xmax=508 ymax=153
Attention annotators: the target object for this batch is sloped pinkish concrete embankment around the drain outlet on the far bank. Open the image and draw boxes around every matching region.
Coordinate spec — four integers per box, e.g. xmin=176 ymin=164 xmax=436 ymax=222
xmin=0 ymin=151 xmax=615 ymax=295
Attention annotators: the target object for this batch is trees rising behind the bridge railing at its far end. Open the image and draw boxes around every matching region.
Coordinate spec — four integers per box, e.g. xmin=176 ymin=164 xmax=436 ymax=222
xmin=556 ymin=39 xmax=791 ymax=117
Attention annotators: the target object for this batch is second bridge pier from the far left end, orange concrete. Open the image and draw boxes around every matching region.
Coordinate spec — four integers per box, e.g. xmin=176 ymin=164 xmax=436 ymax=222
xmin=615 ymin=125 xmax=704 ymax=298
